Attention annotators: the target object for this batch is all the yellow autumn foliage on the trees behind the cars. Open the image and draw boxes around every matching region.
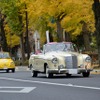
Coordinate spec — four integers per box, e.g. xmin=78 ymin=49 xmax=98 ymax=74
xmin=0 ymin=0 xmax=95 ymax=47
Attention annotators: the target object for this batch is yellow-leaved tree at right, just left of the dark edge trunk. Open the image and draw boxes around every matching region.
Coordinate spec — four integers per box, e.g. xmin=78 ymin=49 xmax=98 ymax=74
xmin=62 ymin=0 xmax=94 ymax=51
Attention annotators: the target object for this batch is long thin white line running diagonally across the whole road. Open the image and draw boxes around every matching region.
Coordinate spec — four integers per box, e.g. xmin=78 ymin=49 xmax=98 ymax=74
xmin=0 ymin=77 xmax=100 ymax=90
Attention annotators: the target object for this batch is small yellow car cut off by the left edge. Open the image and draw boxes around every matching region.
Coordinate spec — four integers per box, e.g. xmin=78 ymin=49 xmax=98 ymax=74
xmin=0 ymin=52 xmax=15 ymax=73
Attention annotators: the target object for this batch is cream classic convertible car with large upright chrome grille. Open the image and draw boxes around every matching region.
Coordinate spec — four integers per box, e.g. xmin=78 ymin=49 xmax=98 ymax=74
xmin=29 ymin=42 xmax=92 ymax=77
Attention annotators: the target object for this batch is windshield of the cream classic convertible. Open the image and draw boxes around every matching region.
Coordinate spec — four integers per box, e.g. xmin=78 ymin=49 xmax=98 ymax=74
xmin=44 ymin=43 xmax=77 ymax=53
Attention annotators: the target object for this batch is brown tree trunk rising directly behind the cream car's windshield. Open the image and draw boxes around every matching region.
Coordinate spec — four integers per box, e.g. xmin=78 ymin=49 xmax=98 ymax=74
xmin=56 ymin=20 xmax=63 ymax=42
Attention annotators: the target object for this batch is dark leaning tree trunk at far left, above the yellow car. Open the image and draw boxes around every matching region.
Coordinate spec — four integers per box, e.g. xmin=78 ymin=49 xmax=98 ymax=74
xmin=0 ymin=13 xmax=8 ymax=51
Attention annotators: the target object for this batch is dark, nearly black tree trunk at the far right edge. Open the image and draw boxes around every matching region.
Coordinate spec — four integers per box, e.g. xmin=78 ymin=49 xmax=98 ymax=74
xmin=93 ymin=0 xmax=100 ymax=67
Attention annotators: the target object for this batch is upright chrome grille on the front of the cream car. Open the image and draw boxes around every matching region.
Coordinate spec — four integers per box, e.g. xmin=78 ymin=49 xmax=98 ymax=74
xmin=65 ymin=56 xmax=77 ymax=69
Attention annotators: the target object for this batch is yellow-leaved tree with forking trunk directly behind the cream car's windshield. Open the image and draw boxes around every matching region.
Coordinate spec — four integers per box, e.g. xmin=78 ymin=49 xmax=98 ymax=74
xmin=29 ymin=0 xmax=81 ymax=41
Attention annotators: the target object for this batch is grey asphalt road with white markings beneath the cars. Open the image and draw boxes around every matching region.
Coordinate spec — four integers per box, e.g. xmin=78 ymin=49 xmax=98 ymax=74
xmin=0 ymin=71 xmax=100 ymax=100
